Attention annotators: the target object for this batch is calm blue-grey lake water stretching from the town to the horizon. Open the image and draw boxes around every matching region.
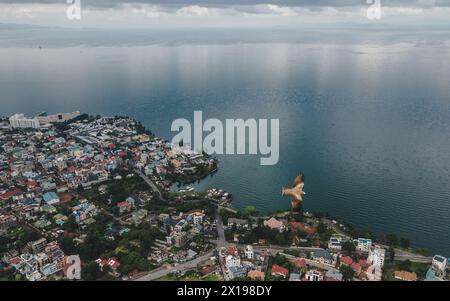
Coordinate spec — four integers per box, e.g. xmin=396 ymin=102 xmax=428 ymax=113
xmin=0 ymin=29 xmax=450 ymax=256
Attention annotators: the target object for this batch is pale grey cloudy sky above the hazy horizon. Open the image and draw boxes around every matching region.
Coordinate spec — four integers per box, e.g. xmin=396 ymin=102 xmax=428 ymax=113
xmin=0 ymin=0 xmax=450 ymax=28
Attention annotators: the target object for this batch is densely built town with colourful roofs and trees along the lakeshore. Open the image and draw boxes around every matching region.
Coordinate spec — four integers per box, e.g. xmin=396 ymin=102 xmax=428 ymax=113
xmin=0 ymin=112 xmax=449 ymax=281
